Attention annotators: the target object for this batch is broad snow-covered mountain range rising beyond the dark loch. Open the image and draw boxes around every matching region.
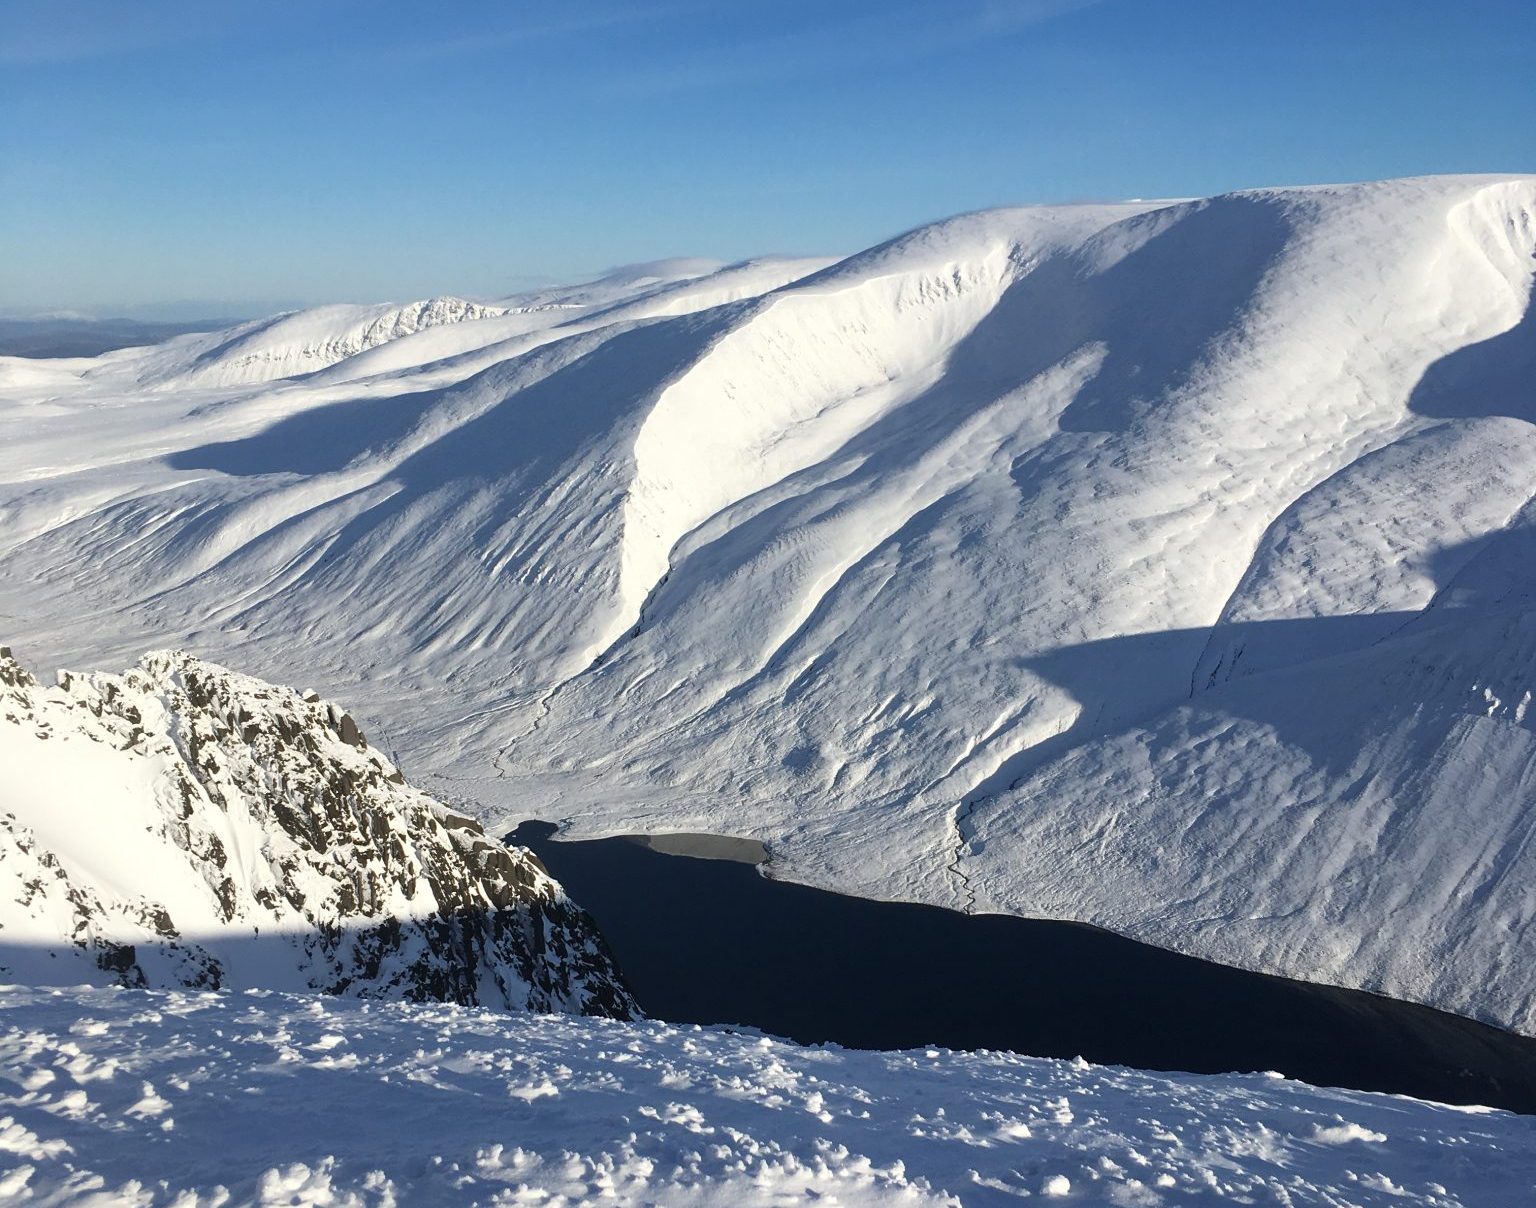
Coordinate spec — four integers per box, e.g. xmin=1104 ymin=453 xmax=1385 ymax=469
xmin=0 ymin=177 xmax=1536 ymax=1033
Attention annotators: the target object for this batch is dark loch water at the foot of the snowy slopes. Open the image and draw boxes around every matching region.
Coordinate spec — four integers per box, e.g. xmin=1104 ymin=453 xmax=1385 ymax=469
xmin=507 ymin=822 xmax=1536 ymax=1113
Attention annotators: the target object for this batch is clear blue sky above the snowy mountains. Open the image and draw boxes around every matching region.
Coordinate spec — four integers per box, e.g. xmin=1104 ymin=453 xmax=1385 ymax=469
xmin=0 ymin=0 xmax=1536 ymax=314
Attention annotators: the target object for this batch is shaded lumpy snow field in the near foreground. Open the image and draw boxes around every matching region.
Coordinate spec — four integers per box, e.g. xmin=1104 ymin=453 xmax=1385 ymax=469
xmin=0 ymin=988 xmax=1536 ymax=1208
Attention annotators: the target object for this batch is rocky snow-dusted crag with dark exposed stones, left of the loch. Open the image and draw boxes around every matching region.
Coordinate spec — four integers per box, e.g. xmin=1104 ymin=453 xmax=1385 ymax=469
xmin=0 ymin=647 xmax=636 ymax=1017
